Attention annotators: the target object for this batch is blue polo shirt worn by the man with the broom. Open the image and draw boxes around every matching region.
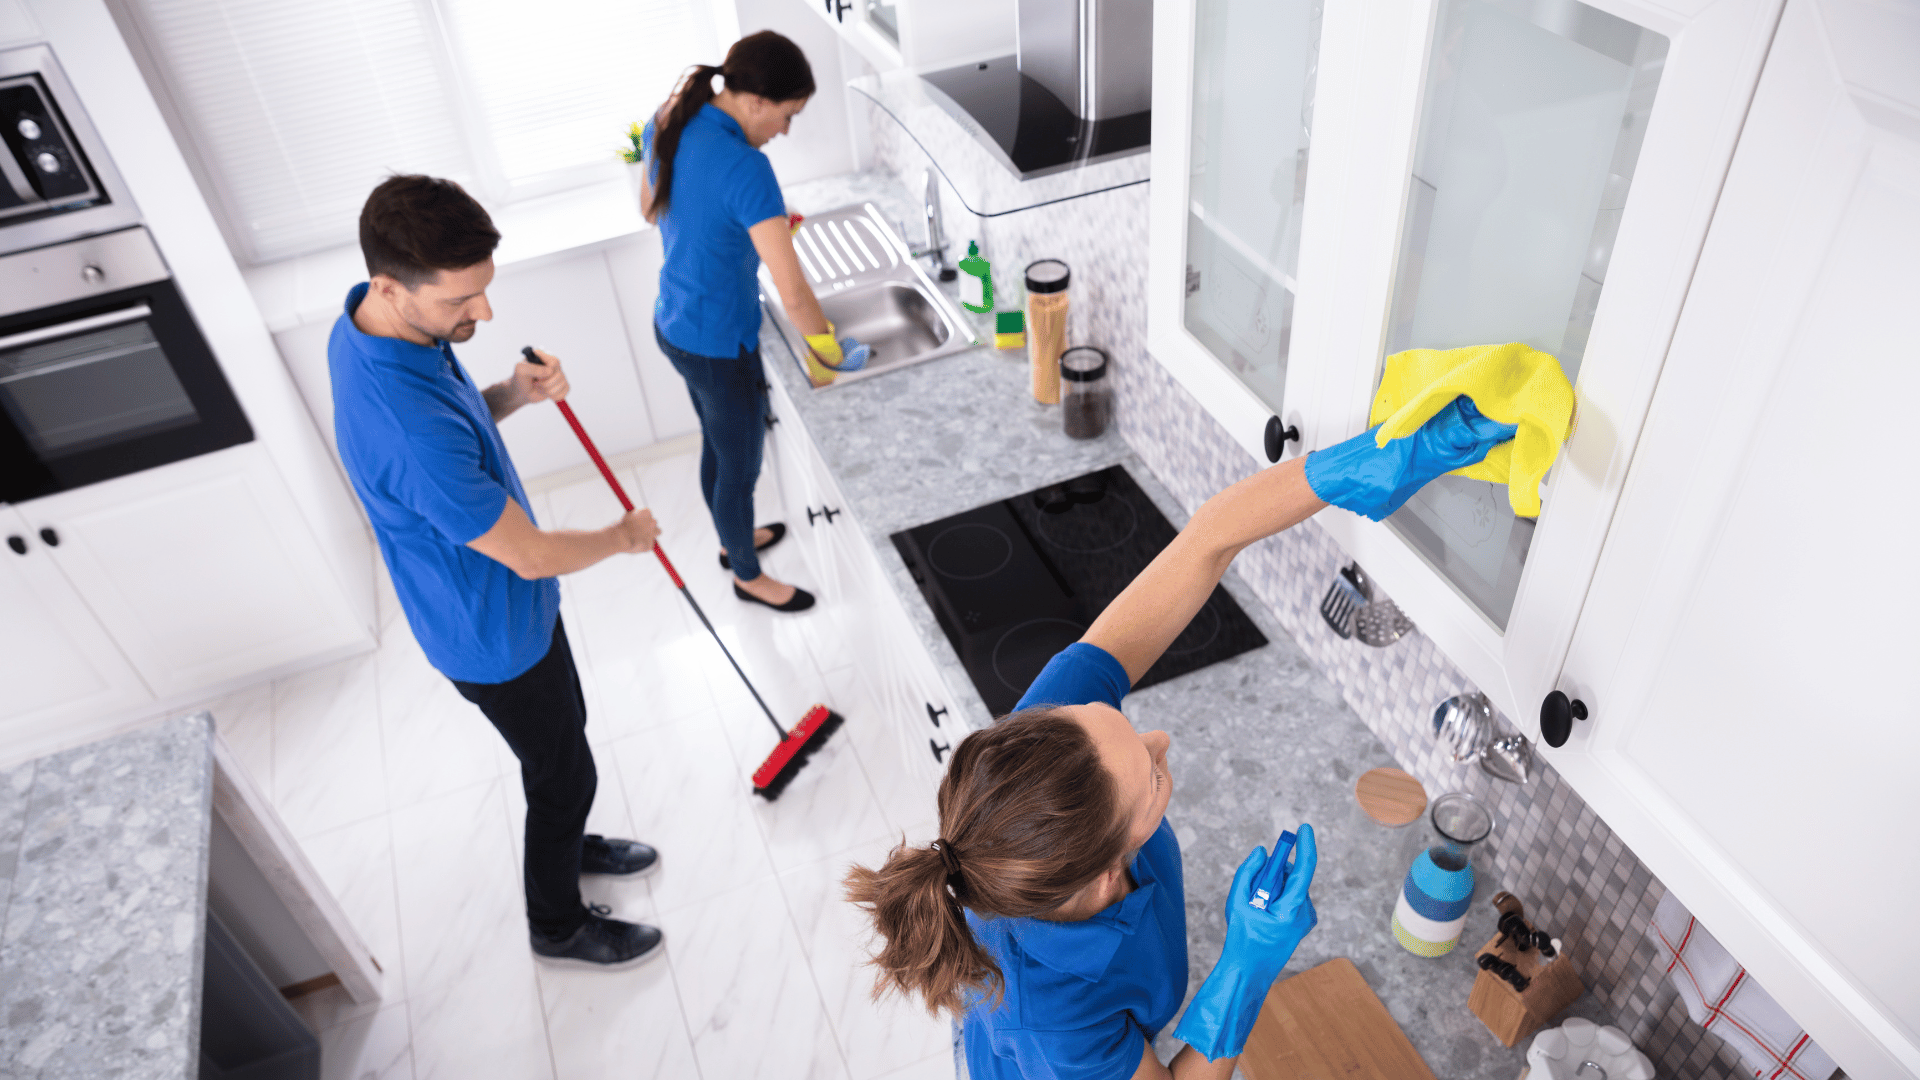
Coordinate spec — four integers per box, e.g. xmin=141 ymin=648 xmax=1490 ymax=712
xmin=326 ymin=282 xmax=561 ymax=682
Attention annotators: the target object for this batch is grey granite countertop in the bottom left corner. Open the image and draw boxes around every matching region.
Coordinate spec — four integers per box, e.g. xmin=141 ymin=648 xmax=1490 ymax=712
xmin=0 ymin=713 xmax=213 ymax=1080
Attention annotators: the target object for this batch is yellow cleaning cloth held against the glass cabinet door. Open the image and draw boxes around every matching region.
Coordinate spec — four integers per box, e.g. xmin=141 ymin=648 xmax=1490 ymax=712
xmin=1367 ymin=342 xmax=1572 ymax=517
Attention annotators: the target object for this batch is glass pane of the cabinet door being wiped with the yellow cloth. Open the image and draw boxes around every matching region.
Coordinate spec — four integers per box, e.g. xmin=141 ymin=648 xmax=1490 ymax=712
xmin=1382 ymin=0 xmax=1668 ymax=630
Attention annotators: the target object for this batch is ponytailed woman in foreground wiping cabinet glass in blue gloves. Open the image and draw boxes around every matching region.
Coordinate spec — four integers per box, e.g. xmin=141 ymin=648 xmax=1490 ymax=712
xmin=847 ymin=398 xmax=1515 ymax=1080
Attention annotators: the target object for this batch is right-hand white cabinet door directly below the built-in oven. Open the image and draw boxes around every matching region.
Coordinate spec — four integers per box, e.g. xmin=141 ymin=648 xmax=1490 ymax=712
xmin=15 ymin=444 xmax=371 ymax=700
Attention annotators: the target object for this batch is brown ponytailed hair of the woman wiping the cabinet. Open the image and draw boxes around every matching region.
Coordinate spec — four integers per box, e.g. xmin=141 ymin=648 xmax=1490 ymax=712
xmin=847 ymin=707 xmax=1129 ymax=1015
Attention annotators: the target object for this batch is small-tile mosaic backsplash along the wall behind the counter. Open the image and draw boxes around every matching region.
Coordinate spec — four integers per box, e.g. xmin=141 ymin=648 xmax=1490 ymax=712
xmin=872 ymin=96 xmax=1843 ymax=1080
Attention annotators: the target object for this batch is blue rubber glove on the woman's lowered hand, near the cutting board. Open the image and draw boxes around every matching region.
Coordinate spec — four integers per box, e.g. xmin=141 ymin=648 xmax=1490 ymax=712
xmin=1173 ymin=824 xmax=1319 ymax=1061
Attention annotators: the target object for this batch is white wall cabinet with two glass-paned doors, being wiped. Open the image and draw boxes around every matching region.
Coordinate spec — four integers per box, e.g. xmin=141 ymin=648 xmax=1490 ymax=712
xmin=1148 ymin=0 xmax=1778 ymax=730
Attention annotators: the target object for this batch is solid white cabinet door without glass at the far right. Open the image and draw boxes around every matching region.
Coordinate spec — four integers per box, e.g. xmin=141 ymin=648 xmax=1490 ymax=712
xmin=1546 ymin=0 xmax=1920 ymax=1078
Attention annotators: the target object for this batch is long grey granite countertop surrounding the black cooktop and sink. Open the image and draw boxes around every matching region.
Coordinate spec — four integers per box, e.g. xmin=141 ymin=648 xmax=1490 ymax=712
xmin=762 ymin=173 xmax=1607 ymax=1078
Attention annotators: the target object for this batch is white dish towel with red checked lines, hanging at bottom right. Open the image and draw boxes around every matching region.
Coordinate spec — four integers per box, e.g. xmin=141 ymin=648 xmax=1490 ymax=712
xmin=1649 ymin=894 xmax=1839 ymax=1080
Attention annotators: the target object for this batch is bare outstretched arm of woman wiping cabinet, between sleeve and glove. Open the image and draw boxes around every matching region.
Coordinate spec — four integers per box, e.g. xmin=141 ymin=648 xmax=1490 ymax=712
xmin=1081 ymin=457 xmax=1327 ymax=682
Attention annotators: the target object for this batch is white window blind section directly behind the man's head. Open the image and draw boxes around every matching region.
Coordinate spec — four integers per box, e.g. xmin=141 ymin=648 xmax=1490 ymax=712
xmin=123 ymin=0 xmax=474 ymax=263
